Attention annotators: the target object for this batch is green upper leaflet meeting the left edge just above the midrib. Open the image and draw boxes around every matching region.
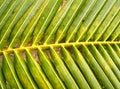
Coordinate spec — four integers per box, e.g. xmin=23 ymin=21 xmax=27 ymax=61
xmin=0 ymin=0 xmax=33 ymax=49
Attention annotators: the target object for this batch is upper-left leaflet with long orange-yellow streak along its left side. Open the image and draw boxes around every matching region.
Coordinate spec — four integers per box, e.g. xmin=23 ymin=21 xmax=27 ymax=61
xmin=21 ymin=0 xmax=48 ymax=46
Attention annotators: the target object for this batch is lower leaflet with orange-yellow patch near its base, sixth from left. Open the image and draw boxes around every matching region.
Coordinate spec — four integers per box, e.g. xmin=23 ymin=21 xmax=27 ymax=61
xmin=61 ymin=47 xmax=90 ymax=89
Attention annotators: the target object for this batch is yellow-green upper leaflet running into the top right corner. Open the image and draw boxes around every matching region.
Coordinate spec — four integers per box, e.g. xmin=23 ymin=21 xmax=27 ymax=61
xmin=93 ymin=0 xmax=120 ymax=41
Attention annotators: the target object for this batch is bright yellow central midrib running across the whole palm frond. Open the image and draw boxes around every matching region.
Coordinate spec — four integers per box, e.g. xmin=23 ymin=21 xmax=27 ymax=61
xmin=0 ymin=41 xmax=120 ymax=54
